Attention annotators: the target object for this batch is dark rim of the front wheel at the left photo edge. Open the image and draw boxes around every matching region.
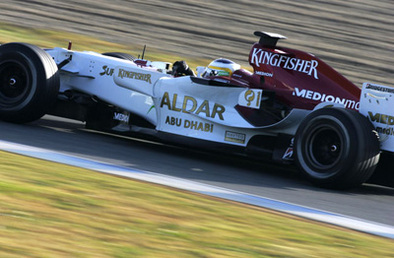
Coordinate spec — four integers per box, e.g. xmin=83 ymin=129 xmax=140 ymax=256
xmin=0 ymin=61 xmax=30 ymax=107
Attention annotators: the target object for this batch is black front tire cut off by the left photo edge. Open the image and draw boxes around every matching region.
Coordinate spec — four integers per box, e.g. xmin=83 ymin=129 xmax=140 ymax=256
xmin=0 ymin=43 xmax=60 ymax=123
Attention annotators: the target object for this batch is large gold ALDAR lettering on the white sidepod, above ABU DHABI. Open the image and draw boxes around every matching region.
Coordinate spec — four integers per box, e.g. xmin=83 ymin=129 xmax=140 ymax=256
xmin=160 ymin=92 xmax=226 ymax=120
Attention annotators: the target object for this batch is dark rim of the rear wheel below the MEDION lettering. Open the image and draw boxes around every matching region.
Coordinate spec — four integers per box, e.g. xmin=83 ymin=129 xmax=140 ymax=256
xmin=305 ymin=125 xmax=344 ymax=176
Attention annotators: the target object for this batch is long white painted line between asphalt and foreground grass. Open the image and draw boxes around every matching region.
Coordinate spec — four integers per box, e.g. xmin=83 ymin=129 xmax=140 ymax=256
xmin=0 ymin=140 xmax=394 ymax=239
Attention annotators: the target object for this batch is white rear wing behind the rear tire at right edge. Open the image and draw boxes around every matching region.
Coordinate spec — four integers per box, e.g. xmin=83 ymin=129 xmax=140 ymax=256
xmin=360 ymin=83 xmax=394 ymax=153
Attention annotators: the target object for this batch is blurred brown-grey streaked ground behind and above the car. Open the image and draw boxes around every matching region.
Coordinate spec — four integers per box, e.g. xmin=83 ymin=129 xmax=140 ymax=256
xmin=0 ymin=0 xmax=394 ymax=87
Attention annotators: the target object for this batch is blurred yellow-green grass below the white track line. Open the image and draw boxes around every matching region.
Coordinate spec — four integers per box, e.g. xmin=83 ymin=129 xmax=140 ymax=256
xmin=0 ymin=152 xmax=394 ymax=257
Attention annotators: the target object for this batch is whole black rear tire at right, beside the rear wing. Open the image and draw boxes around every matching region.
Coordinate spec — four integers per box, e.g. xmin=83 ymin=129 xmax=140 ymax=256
xmin=294 ymin=108 xmax=380 ymax=189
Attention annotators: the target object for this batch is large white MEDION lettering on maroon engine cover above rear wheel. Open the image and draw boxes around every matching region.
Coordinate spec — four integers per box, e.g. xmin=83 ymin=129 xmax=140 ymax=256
xmin=293 ymin=87 xmax=360 ymax=110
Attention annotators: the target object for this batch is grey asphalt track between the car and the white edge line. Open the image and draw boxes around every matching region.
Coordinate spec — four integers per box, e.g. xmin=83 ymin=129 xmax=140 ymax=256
xmin=0 ymin=116 xmax=394 ymax=232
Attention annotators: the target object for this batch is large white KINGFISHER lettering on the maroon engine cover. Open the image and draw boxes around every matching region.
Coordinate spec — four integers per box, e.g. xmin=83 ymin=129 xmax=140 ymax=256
xmin=250 ymin=48 xmax=319 ymax=79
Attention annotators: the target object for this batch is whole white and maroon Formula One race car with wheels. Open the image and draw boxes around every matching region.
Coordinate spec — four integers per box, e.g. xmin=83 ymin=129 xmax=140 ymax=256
xmin=0 ymin=31 xmax=394 ymax=189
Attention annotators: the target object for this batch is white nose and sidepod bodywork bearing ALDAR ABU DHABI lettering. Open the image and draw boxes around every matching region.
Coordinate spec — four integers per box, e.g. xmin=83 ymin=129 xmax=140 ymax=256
xmin=47 ymin=48 xmax=310 ymax=146
